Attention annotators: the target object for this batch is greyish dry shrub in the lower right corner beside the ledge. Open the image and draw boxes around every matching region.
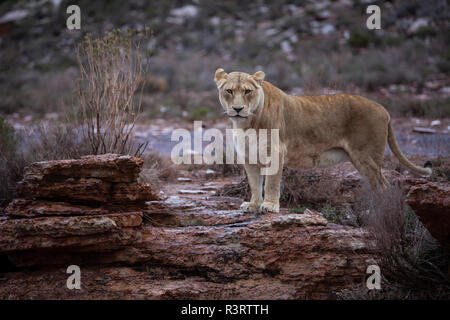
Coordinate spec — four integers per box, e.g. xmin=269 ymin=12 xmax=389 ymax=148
xmin=352 ymin=185 xmax=450 ymax=299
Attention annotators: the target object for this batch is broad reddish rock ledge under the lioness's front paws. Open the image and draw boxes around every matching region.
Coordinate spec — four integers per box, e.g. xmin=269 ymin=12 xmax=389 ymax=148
xmin=0 ymin=197 xmax=376 ymax=299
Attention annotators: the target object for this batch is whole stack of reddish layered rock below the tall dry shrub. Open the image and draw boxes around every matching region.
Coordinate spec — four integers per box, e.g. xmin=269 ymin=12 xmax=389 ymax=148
xmin=0 ymin=154 xmax=158 ymax=266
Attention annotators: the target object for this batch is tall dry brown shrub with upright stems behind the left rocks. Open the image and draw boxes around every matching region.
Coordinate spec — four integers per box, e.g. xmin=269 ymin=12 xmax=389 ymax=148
xmin=76 ymin=30 xmax=149 ymax=156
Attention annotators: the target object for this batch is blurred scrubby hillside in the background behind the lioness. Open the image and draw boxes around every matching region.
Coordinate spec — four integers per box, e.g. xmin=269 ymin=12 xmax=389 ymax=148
xmin=0 ymin=0 xmax=450 ymax=118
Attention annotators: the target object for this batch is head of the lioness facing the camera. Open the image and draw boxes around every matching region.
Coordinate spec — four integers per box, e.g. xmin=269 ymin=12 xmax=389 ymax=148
xmin=214 ymin=69 xmax=264 ymax=120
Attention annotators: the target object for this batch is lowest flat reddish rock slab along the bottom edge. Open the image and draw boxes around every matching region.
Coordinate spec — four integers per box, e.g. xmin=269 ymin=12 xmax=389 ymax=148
xmin=0 ymin=267 xmax=327 ymax=300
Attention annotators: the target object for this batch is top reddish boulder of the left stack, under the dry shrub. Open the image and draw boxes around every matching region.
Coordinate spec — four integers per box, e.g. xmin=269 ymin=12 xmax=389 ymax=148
xmin=5 ymin=154 xmax=159 ymax=217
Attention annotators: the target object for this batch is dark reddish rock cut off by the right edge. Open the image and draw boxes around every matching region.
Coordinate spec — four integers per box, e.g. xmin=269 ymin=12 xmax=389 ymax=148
xmin=406 ymin=181 xmax=450 ymax=250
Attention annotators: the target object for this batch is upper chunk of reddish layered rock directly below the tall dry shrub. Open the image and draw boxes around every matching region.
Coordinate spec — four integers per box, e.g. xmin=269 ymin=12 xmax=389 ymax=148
xmin=6 ymin=154 xmax=157 ymax=209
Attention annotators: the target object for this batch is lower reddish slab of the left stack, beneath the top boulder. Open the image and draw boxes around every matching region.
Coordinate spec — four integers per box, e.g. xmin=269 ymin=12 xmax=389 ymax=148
xmin=0 ymin=212 xmax=142 ymax=252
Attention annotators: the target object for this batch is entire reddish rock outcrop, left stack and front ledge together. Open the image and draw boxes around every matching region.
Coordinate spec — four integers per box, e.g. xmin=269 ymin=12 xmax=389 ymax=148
xmin=0 ymin=155 xmax=448 ymax=299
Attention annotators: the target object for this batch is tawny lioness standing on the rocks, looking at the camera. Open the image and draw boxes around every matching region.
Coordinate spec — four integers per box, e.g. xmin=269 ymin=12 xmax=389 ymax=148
xmin=214 ymin=68 xmax=431 ymax=212
